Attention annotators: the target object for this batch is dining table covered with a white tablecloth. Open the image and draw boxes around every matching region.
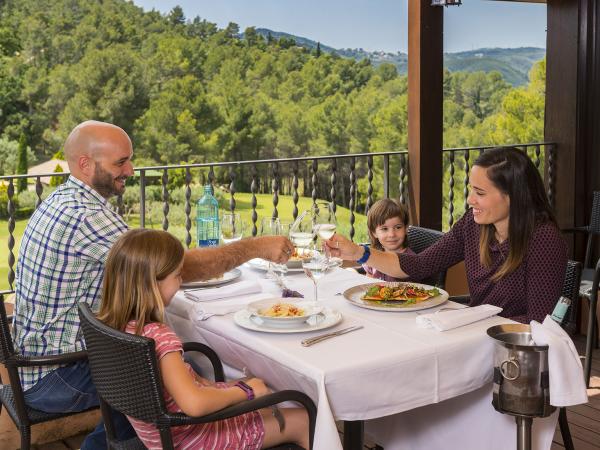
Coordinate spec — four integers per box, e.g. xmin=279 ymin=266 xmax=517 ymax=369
xmin=166 ymin=264 xmax=557 ymax=450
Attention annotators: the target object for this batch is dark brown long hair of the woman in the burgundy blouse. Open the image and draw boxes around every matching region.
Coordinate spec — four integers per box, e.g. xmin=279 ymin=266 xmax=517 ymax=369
xmin=474 ymin=147 xmax=556 ymax=281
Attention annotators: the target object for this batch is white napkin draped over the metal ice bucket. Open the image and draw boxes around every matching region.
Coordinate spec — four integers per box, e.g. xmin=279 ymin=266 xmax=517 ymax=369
xmin=530 ymin=316 xmax=588 ymax=407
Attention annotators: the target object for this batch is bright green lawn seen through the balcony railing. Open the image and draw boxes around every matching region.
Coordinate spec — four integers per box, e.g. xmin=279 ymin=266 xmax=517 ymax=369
xmin=0 ymin=193 xmax=368 ymax=290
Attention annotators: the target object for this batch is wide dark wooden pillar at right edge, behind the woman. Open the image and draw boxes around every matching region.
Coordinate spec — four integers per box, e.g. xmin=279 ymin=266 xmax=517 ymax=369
xmin=544 ymin=0 xmax=600 ymax=260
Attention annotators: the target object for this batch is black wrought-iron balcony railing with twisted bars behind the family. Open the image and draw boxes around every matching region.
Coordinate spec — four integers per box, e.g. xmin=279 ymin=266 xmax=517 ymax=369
xmin=0 ymin=143 xmax=556 ymax=289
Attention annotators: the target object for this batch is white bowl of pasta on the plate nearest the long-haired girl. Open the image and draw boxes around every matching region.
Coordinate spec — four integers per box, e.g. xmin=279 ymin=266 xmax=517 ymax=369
xmin=246 ymin=298 xmax=323 ymax=327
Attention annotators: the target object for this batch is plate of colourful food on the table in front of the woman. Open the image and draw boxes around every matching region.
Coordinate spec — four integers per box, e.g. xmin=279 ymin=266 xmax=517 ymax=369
xmin=344 ymin=281 xmax=448 ymax=312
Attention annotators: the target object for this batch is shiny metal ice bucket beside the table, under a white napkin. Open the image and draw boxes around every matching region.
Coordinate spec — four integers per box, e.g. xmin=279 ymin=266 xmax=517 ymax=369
xmin=487 ymin=324 xmax=556 ymax=417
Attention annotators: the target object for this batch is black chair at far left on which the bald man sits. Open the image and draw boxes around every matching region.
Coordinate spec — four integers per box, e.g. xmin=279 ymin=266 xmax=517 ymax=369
xmin=0 ymin=295 xmax=97 ymax=450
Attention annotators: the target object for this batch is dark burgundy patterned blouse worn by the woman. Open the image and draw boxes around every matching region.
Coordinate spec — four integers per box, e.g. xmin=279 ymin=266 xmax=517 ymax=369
xmin=398 ymin=210 xmax=567 ymax=323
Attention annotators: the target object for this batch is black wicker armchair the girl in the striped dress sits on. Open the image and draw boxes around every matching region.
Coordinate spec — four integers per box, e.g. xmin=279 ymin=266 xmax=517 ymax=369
xmin=79 ymin=303 xmax=317 ymax=449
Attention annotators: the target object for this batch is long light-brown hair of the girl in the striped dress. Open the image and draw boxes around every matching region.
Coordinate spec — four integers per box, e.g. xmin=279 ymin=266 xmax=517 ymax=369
xmin=98 ymin=229 xmax=184 ymax=334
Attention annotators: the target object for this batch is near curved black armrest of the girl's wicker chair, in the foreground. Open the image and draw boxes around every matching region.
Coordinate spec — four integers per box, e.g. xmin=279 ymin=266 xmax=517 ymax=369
xmin=164 ymin=390 xmax=317 ymax=447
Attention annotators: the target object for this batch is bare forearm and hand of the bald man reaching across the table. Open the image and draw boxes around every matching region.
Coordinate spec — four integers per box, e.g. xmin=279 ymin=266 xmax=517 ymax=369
xmin=181 ymin=236 xmax=294 ymax=281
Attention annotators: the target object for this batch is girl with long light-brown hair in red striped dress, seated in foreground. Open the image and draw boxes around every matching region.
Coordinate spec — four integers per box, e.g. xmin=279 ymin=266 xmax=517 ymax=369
xmin=98 ymin=229 xmax=308 ymax=449
